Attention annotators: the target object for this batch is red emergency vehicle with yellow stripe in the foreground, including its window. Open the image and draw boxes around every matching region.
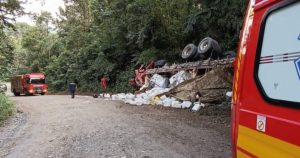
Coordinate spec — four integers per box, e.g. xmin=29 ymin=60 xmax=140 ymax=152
xmin=232 ymin=0 xmax=300 ymax=158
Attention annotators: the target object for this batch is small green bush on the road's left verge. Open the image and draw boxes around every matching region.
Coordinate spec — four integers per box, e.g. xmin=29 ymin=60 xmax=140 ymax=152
xmin=0 ymin=94 xmax=15 ymax=124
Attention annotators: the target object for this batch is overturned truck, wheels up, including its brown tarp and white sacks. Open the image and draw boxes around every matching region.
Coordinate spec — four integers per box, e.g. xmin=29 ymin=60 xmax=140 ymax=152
xmin=128 ymin=38 xmax=235 ymax=107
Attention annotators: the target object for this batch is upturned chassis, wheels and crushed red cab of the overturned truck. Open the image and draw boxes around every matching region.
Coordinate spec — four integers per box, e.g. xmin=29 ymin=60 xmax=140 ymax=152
xmin=129 ymin=37 xmax=235 ymax=90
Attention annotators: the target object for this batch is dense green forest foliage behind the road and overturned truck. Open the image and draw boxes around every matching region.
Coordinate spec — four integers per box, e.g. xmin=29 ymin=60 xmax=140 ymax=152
xmin=4 ymin=0 xmax=247 ymax=91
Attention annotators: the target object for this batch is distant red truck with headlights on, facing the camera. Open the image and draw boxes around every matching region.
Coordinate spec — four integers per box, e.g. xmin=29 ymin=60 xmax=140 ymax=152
xmin=11 ymin=73 xmax=48 ymax=96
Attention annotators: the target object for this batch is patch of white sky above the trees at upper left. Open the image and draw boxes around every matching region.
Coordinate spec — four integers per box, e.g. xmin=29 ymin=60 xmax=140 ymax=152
xmin=16 ymin=0 xmax=64 ymax=25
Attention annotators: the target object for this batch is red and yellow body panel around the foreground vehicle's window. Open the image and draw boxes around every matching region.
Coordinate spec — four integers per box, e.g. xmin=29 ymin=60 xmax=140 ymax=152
xmin=233 ymin=0 xmax=300 ymax=157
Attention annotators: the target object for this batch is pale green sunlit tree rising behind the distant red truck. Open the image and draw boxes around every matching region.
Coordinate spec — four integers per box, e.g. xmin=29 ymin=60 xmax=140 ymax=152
xmin=11 ymin=12 xmax=59 ymax=73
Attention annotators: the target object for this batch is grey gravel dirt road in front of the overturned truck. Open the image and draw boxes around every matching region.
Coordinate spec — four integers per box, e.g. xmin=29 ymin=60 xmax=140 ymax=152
xmin=0 ymin=95 xmax=230 ymax=158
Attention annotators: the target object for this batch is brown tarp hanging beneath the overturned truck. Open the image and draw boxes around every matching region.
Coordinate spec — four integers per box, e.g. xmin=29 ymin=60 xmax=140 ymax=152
xmin=163 ymin=67 xmax=233 ymax=103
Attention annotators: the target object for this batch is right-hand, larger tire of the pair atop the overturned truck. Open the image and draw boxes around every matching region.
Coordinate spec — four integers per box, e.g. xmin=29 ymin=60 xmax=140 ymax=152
xmin=198 ymin=37 xmax=222 ymax=59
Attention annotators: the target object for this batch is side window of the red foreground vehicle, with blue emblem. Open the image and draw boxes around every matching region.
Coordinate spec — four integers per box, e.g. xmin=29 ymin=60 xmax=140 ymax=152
xmin=255 ymin=1 xmax=300 ymax=105
